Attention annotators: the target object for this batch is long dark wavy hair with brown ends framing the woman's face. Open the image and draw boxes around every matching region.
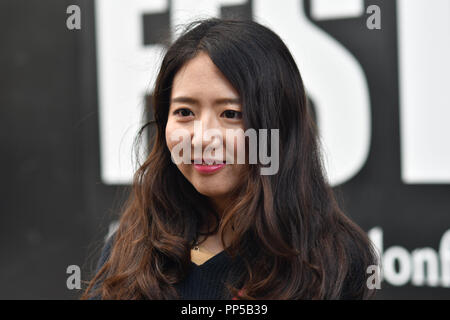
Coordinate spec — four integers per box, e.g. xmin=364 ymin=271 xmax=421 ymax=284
xmin=82 ymin=18 xmax=376 ymax=299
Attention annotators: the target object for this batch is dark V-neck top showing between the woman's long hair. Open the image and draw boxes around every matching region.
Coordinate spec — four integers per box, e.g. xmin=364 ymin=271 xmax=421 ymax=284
xmin=94 ymin=232 xmax=244 ymax=300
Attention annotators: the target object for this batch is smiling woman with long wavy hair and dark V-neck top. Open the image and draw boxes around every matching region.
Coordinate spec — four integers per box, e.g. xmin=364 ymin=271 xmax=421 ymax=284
xmin=82 ymin=19 xmax=376 ymax=299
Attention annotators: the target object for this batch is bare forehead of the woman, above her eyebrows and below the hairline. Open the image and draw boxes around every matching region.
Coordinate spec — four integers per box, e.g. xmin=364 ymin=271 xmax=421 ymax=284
xmin=171 ymin=52 xmax=239 ymax=99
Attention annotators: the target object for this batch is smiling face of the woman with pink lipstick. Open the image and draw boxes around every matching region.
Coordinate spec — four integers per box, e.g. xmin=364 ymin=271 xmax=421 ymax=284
xmin=166 ymin=52 xmax=245 ymax=209
